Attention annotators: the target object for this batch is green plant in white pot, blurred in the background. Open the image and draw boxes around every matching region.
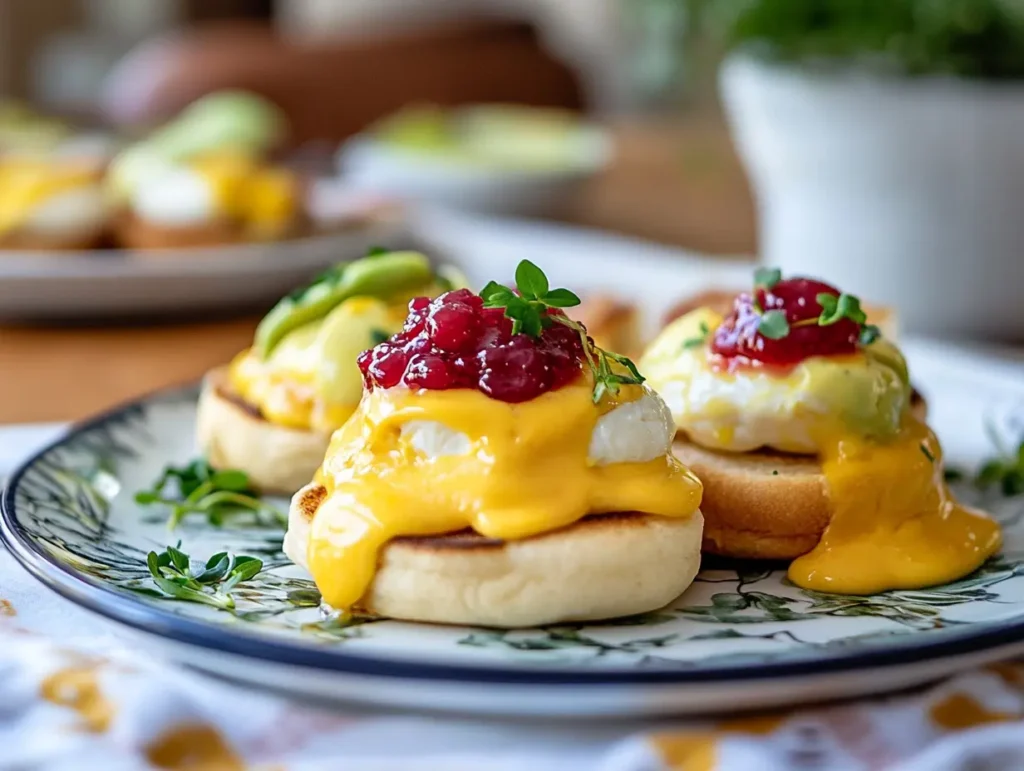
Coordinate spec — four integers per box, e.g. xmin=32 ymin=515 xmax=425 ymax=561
xmin=708 ymin=0 xmax=1024 ymax=339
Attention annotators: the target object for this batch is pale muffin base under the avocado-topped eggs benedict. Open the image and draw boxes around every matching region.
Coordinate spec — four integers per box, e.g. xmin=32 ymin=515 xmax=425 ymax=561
xmin=196 ymin=367 xmax=331 ymax=496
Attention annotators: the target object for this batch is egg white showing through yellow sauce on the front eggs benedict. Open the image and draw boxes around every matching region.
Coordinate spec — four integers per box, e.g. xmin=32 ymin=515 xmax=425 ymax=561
xmin=401 ymin=390 xmax=676 ymax=466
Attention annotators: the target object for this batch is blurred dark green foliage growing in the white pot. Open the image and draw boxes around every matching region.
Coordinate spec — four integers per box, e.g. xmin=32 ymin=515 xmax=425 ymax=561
xmin=716 ymin=0 xmax=1024 ymax=79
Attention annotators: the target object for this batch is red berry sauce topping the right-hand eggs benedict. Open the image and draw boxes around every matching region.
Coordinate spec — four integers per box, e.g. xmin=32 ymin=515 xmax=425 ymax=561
xmin=711 ymin=279 xmax=860 ymax=367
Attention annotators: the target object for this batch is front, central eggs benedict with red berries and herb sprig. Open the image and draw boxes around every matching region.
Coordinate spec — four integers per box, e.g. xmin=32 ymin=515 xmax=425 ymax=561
xmin=285 ymin=261 xmax=701 ymax=628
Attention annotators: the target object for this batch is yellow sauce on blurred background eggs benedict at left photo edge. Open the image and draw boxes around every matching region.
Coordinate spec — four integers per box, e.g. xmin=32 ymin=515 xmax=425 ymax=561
xmin=0 ymin=159 xmax=98 ymax=234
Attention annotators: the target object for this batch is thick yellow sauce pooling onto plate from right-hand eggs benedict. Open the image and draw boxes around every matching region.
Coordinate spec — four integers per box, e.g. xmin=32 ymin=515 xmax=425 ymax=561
xmin=788 ymin=418 xmax=1001 ymax=594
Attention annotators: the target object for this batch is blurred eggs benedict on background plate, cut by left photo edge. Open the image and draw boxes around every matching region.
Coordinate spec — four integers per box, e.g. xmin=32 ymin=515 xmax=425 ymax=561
xmin=0 ymin=155 xmax=110 ymax=250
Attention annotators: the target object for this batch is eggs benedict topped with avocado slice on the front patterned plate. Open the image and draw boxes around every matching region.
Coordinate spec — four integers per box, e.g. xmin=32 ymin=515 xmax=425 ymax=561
xmin=198 ymin=252 xmax=458 ymax=495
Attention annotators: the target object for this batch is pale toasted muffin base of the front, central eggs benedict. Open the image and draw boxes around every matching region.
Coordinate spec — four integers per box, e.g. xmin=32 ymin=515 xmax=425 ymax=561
xmin=285 ymin=483 xmax=703 ymax=629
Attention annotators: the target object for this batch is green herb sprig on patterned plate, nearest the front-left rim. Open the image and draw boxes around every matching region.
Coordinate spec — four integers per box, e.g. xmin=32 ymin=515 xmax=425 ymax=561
xmin=145 ymin=541 xmax=263 ymax=610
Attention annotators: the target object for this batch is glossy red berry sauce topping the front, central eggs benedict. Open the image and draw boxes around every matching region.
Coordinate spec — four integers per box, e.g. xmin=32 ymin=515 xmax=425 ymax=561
xmin=358 ymin=289 xmax=584 ymax=402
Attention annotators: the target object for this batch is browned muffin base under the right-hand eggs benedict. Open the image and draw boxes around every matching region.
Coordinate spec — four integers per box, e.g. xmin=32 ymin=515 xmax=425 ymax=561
xmin=672 ymin=391 xmax=928 ymax=560
